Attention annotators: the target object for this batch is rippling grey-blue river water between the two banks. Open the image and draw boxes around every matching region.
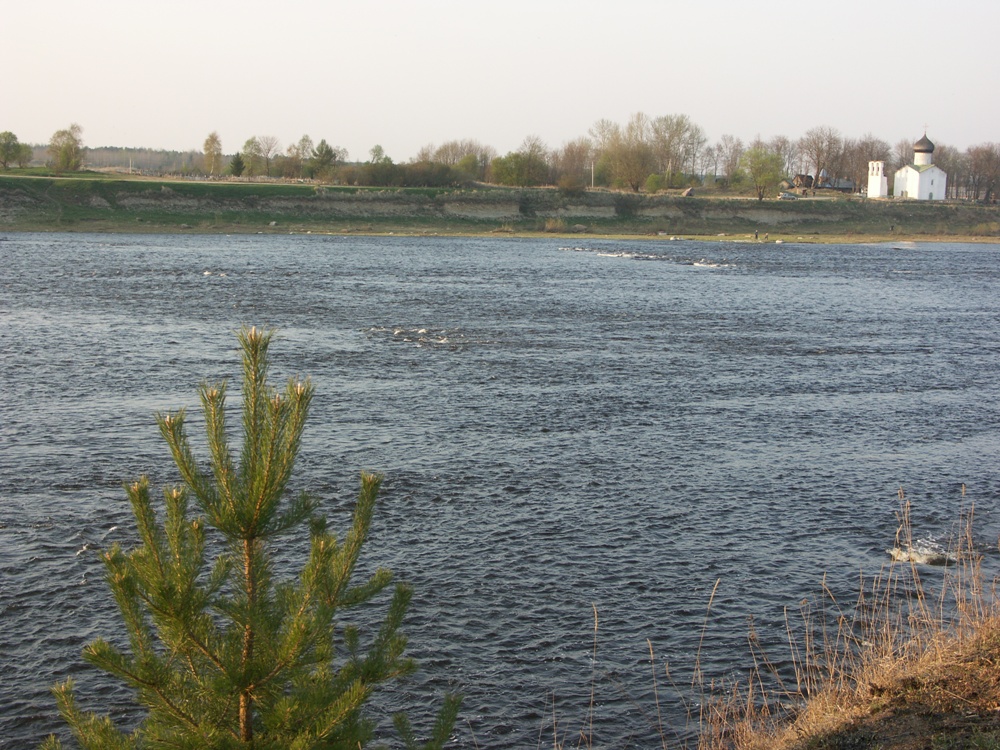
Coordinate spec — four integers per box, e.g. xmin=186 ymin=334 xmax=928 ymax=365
xmin=0 ymin=234 xmax=1000 ymax=747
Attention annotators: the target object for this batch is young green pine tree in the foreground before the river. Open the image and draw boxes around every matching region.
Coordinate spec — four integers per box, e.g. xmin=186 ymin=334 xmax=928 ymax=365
xmin=46 ymin=328 xmax=461 ymax=750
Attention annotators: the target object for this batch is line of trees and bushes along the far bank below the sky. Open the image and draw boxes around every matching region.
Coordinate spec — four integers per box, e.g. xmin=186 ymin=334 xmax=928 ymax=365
xmin=0 ymin=117 xmax=1000 ymax=201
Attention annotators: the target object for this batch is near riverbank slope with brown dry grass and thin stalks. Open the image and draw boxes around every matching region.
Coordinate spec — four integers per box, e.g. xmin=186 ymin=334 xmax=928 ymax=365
xmin=539 ymin=491 xmax=1000 ymax=750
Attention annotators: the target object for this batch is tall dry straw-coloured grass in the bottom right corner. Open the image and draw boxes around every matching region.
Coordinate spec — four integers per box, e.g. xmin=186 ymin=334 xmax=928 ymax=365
xmin=698 ymin=493 xmax=1000 ymax=750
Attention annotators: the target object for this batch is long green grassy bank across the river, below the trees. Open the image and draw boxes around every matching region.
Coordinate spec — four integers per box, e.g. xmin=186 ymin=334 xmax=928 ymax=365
xmin=0 ymin=174 xmax=1000 ymax=242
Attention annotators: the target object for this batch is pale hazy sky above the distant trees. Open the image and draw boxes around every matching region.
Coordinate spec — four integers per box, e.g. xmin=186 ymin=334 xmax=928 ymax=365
xmin=0 ymin=0 xmax=1000 ymax=162
